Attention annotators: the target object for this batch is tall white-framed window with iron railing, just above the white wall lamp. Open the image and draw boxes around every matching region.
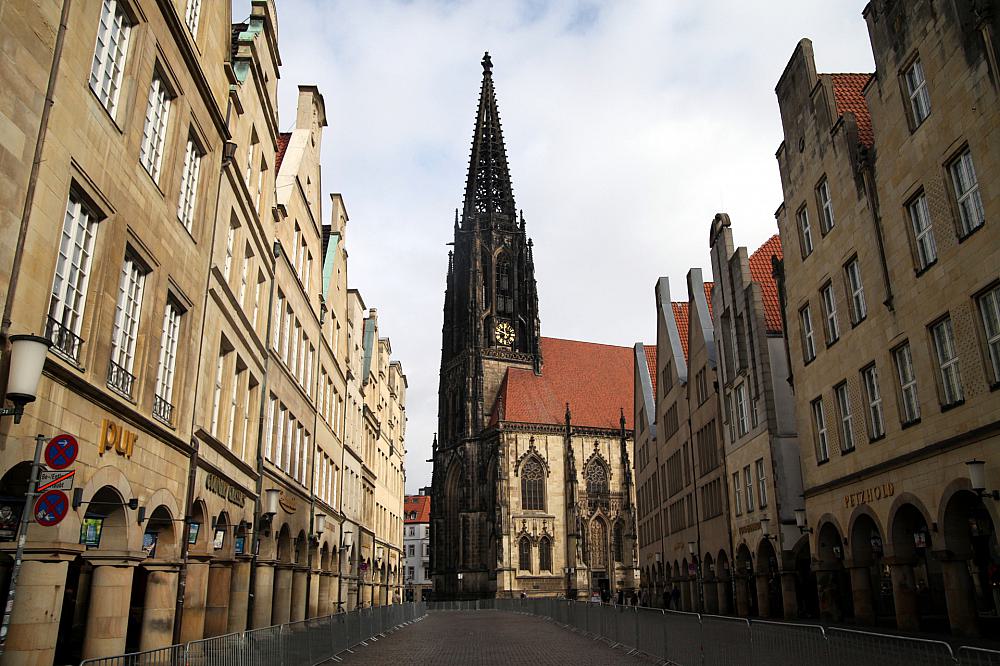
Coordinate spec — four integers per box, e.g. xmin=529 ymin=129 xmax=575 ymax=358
xmin=46 ymin=192 xmax=97 ymax=361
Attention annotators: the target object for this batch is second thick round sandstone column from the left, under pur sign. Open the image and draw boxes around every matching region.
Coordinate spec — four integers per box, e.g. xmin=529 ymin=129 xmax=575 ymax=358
xmin=83 ymin=551 xmax=139 ymax=659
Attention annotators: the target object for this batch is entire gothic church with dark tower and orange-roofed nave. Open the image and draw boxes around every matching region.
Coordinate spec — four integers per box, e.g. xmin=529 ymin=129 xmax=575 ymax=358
xmin=431 ymin=54 xmax=638 ymax=599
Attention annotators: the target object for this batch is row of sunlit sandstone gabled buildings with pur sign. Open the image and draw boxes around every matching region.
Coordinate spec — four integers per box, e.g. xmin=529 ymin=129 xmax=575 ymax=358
xmin=0 ymin=0 xmax=405 ymax=664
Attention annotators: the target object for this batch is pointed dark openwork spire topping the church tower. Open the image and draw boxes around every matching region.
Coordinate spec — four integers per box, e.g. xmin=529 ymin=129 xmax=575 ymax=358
xmin=463 ymin=52 xmax=517 ymax=227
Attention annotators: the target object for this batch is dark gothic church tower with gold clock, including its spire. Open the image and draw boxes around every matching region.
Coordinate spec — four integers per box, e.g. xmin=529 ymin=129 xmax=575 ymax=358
xmin=431 ymin=53 xmax=542 ymax=596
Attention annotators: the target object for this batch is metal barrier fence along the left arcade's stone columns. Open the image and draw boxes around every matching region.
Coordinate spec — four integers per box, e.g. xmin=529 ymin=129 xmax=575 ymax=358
xmin=80 ymin=602 xmax=427 ymax=666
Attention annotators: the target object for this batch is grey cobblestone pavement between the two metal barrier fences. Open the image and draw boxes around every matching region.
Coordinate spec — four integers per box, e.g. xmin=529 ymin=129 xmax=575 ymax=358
xmin=332 ymin=611 xmax=655 ymax=666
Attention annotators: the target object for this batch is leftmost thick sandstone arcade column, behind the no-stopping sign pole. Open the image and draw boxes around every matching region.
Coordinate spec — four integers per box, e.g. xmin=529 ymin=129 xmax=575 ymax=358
xmin=3 ymin=544 xmax=77 ymax=664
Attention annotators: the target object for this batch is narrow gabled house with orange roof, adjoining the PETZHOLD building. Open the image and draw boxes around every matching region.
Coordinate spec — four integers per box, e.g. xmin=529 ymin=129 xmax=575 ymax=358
xmin=709 ymin=218 xmax=817 ymax=619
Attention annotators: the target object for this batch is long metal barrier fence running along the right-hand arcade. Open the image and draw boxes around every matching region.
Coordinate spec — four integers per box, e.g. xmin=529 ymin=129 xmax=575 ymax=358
xmin=442 ymin=598 xmax=1000 ymax=666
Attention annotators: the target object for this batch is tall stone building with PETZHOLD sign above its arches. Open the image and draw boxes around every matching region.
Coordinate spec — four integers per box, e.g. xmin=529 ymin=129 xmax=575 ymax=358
xmin=776 ymin=0 xmax=1000 ymax=635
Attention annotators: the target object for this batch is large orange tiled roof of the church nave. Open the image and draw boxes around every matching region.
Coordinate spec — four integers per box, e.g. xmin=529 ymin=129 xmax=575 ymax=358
xmin=490 ymin=338 xmax=635 ymax=430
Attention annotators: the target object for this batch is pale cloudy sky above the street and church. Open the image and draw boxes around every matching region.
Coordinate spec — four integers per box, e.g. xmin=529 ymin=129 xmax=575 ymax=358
xmin=233 ymin=0 xmax=874 ymax=494
